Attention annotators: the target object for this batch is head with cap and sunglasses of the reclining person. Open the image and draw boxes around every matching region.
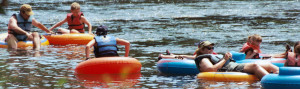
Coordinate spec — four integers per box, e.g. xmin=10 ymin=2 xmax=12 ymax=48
xmin=196 ymin=41 xmax=215 ymax=56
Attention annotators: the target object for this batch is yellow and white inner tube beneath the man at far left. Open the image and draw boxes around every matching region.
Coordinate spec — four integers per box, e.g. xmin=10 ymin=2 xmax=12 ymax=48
xmin=0 ymin=33 xmax=49 ymax=48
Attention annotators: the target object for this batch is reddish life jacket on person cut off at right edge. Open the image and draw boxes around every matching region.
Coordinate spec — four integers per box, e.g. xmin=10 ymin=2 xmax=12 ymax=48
xmin=285 ymin=52 xmax=300 ymax=66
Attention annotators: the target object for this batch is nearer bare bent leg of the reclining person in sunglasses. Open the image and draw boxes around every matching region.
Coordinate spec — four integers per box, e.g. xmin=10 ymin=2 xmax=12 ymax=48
xmin=244 ymin=63 xmax=269 ymax=79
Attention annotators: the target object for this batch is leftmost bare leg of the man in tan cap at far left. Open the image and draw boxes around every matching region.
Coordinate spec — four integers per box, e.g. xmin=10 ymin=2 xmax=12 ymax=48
xmin=6 ymin=34 xmax=18 ymax=49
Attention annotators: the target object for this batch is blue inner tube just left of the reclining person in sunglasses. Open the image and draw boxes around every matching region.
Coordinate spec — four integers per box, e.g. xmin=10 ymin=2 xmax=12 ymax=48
xmin=157 ymin=59 xmax=199 ymax=75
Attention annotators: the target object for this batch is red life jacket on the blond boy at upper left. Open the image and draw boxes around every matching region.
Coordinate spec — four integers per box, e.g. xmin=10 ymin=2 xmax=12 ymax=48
xmin=67 ymin=12 xmax=84 ymax=33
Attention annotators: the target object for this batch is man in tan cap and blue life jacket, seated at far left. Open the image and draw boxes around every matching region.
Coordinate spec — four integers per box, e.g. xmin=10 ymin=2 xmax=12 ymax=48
xmin=6 ymin=4 xmax=51 ymax=50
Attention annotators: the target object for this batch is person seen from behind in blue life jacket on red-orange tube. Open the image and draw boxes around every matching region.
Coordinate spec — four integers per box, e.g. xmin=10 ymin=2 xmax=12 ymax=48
xmin=85 ymin=25 xmax=130 ymax=60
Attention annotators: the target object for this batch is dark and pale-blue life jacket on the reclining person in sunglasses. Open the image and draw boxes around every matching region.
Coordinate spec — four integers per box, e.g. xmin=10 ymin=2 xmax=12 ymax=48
xmin=195 ymin=54 xmax=231 ymax=72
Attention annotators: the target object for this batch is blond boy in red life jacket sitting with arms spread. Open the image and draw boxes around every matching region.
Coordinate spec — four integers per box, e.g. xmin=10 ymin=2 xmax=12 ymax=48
xmin=50 ymin=2 xmax=93 ymax=34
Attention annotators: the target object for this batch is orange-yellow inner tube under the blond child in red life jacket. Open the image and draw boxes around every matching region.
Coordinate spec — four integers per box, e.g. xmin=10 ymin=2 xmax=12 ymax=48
xmin=44 ymin=33 xmax=94 ymax=45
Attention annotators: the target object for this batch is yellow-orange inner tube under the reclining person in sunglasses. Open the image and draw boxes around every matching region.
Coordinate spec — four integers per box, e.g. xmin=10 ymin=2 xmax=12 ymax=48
xmin=197 ymin=72 xmax=259 ymax=82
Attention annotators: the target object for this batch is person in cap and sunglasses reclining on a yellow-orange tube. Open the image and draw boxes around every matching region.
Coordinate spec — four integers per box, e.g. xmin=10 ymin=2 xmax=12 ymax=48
xmin=195 ymin=41 xmax=279 ymax=79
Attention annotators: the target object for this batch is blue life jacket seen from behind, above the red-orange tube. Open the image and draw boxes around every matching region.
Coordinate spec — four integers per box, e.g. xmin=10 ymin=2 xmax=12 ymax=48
xmin=94 ymin=35 xmax=119 ymax=57
